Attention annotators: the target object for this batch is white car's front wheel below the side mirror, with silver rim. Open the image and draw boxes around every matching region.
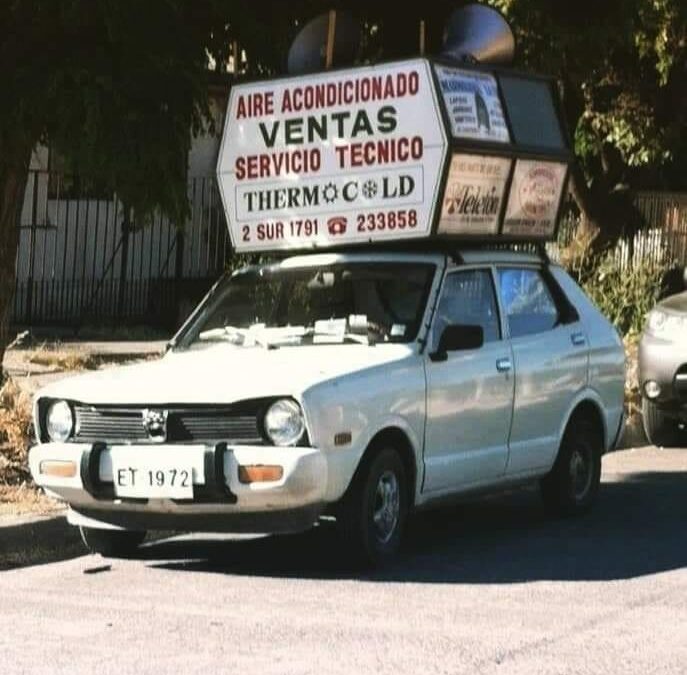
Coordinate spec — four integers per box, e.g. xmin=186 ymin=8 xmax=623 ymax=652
xmin=337 ymin=447 xmax=409 ymax=566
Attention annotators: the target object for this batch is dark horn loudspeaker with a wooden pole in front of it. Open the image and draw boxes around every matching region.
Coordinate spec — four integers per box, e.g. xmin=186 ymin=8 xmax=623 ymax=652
xmin=287 ymin=12 xmax=361 ymax=75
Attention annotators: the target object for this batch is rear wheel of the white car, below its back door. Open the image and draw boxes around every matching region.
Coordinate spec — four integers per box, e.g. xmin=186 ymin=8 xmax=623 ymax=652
xmin=539 ymin=418 xmax=603 ymax=516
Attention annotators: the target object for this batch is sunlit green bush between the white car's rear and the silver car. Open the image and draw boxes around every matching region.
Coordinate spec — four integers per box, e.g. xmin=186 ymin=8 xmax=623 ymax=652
xmin=571 ymin=252 xmax=668 ymax=336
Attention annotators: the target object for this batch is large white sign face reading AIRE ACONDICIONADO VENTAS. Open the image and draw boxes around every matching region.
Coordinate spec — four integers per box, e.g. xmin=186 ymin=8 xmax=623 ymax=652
xmin=217 ymin=59 xmax=448 ymax=251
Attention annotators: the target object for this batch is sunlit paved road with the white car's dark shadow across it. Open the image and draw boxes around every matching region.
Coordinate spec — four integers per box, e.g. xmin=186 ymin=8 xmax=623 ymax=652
xmin=0 ymin=449 xmax=687 ymax=675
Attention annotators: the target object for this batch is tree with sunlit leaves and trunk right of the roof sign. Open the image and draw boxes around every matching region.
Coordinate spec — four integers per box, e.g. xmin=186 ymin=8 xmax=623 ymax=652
xmin=491 ymin=0 xmax=687 ymax=255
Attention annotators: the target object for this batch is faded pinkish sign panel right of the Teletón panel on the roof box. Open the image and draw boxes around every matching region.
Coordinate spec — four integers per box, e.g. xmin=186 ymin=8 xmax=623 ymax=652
xmin=503 ymin=159 xmax=567 ymax=237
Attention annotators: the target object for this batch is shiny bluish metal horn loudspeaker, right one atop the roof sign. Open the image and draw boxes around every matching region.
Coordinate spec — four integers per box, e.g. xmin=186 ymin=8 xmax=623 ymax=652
xmin=443 ymin=4 xmax=515 ymax=65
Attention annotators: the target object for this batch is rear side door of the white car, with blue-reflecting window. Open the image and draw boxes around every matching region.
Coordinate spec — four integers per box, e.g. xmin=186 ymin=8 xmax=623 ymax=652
xmin=497 ymin=266 xmax=589 ymax=475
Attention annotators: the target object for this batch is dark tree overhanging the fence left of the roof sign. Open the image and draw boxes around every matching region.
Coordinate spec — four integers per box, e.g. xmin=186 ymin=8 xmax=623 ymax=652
xmin=0 ymin=0 xmax=218 ymax=374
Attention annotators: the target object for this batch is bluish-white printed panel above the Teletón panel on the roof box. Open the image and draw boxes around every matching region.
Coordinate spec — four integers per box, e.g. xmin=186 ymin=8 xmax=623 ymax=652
xmin=434 ymin=65 xmax=510 ymax=143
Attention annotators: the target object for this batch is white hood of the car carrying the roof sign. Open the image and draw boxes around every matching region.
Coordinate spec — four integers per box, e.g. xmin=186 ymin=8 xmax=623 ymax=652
xmin=38 ymin=344 xmax=414 ymax=405
